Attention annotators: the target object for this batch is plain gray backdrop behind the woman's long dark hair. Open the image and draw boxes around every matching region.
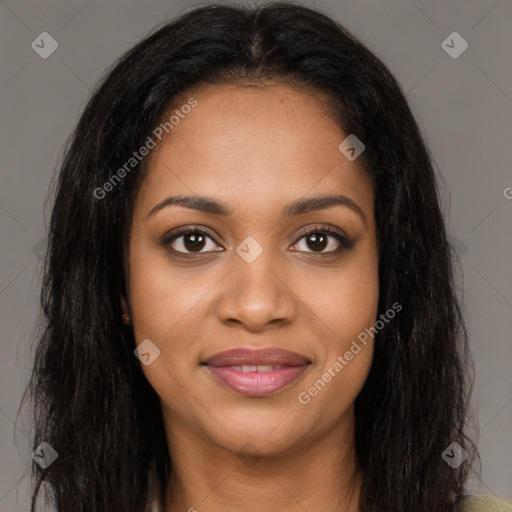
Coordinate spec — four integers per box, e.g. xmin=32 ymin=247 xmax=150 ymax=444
xmin=0 ymin=0 xmax=512 ymax=512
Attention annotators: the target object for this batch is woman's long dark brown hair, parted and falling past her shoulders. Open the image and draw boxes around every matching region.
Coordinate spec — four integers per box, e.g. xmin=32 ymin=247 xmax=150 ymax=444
xmin=17 ymin=2 xmax=478 ymax=512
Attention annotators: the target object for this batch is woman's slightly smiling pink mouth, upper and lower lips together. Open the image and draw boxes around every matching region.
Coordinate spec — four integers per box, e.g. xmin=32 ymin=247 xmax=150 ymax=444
xmin=202 ymin=347 xmax=311 ymax=397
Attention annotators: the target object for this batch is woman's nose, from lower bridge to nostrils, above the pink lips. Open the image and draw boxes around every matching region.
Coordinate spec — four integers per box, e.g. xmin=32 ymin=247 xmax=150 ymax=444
xmin=218 ymin=252 xmax=297 ymax=332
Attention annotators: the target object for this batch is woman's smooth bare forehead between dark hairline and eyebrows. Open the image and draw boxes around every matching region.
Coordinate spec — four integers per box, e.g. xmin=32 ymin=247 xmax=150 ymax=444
xmin=132 ymin=84 xmax=372 ymax=220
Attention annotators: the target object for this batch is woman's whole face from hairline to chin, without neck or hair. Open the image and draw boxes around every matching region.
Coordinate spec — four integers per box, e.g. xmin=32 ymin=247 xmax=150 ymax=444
xmin=123 ymin=84 xmax=378 ymax=454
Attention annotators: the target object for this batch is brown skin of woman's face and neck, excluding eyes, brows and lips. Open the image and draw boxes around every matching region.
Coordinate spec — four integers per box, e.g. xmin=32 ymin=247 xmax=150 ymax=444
xmin=122 ymin=83 xmax=378 ymax=512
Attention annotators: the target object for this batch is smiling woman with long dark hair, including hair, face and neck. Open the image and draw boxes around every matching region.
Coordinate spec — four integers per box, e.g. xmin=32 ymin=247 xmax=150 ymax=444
xmin=21 ymin=3 xmax=508 ymax=512
